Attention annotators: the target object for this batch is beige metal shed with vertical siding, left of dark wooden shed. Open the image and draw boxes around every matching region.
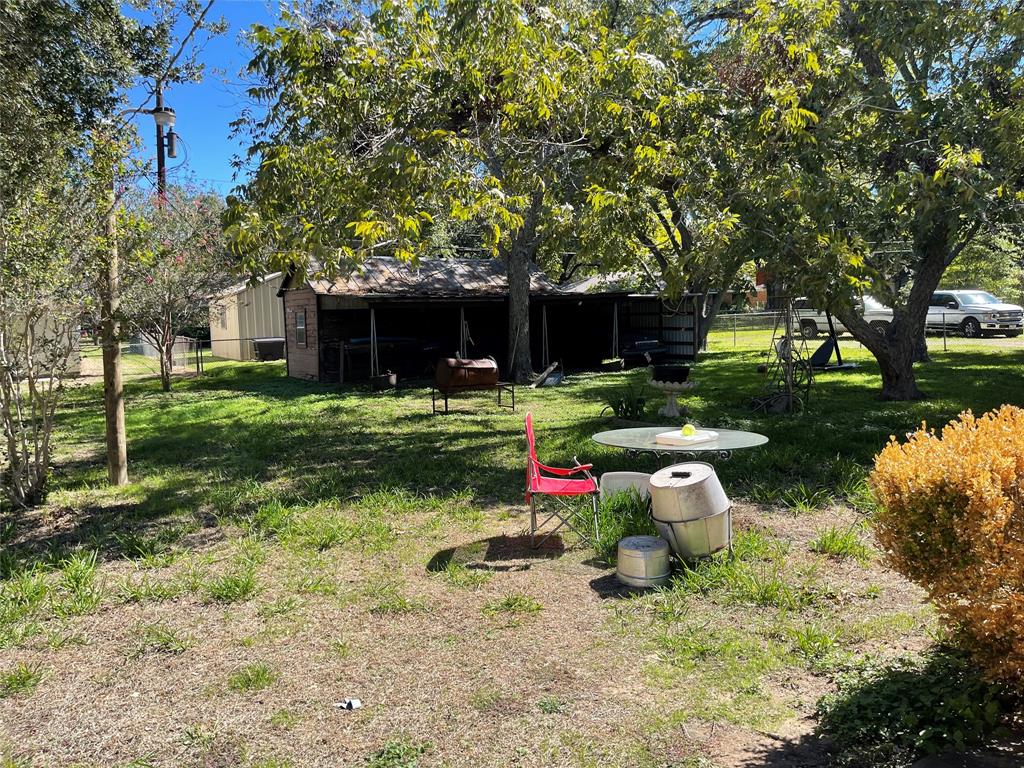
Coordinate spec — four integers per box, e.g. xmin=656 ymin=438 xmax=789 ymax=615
xmin=210 ymin=272 xmax=285 ymax=360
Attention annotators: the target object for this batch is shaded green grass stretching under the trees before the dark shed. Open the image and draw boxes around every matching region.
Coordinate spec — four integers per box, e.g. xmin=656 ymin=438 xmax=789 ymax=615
xmin=25 ymin=352 xmax=1024 ymax=569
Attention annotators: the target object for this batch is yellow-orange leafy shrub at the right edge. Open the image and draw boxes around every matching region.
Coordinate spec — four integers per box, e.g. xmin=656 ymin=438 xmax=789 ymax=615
xmin=871 ymin=406 xmax=1024 ymax=688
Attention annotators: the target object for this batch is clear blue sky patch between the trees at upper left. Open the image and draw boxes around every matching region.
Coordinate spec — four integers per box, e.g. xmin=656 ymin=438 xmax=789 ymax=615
xmin=129 ymin=0 xmax=278 ymax=194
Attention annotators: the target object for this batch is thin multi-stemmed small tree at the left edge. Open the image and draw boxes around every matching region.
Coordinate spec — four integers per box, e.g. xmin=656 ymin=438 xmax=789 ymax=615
xmin=0 ymin=164 xmax=96 ymax=509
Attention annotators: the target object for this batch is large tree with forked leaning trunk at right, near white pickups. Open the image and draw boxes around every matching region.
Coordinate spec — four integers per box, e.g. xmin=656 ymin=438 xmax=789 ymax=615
xmin=727 ymin=0 xmax=1024 ymax=399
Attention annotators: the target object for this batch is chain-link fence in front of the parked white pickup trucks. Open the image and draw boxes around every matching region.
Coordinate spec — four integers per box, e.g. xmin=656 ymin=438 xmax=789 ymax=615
xmin=707 ymin=312 xmax=1024 ymax=353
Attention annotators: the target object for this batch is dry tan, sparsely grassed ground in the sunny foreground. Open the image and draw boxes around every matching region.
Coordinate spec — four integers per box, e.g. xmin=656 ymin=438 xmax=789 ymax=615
xmin=0 ymin=506 xmax=925 ymax=767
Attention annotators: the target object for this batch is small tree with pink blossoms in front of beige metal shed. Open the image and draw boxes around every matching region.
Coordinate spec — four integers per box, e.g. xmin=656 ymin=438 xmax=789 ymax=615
xmin=123 ymin=187 xmax=231 ymax=392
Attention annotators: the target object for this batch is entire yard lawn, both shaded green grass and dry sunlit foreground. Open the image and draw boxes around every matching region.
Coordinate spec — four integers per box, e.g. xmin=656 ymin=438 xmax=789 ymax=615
xmin=0 ymin=345 xmax=1024 ymax=768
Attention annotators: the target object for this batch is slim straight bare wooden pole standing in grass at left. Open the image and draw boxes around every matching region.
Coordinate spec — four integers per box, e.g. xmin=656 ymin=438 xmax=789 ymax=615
xmin=98 ymin=177 xmax=128 ymax=485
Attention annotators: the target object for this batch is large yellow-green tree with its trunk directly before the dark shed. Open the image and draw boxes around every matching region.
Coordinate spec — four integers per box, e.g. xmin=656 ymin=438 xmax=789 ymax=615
xmin=227 ymin=0 xmax=761 ymax=379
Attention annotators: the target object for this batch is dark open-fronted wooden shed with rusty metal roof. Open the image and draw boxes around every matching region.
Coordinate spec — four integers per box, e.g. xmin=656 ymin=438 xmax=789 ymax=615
xmin=278 ymin=257 xmax=695 ymax=382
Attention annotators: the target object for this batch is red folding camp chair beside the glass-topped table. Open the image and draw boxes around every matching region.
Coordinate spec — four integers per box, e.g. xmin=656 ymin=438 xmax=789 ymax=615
xmin=526 ymin=414 xmax=601 ymax=549
